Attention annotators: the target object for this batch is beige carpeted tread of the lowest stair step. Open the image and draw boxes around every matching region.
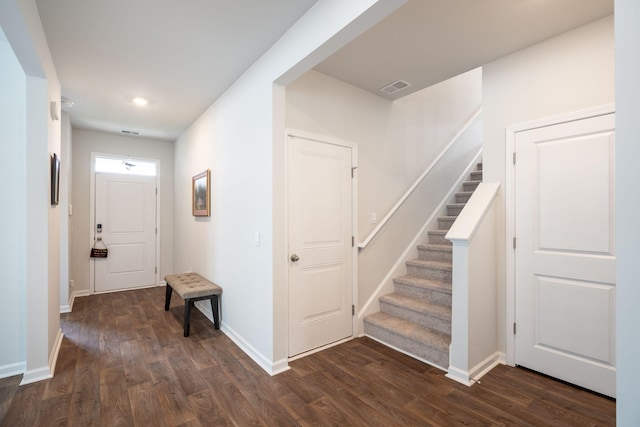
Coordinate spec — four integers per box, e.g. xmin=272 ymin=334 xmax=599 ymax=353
xmin=364 ymin=313 xmax=451 ymax=352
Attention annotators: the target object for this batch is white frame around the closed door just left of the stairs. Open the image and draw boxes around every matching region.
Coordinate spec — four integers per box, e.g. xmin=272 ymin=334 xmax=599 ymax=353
xmin=284 ymin=129 xmax=359 ymax=361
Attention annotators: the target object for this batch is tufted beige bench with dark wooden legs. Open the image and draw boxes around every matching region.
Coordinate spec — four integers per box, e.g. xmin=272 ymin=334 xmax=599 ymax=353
xmin=164 ymin=273 xmax=222 ymax=337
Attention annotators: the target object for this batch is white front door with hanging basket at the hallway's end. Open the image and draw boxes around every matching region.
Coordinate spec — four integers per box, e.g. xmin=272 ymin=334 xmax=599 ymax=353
xmin=94 ymin=173 xmax=156 ymax=292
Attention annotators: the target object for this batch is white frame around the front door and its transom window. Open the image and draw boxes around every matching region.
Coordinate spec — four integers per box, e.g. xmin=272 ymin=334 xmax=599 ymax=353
xmin=87 ymin=152 xmax=162 ymax=295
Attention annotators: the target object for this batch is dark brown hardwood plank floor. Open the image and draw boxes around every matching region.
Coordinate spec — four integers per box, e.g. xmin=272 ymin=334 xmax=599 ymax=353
xmin=0 ymin=288 xmax=615 ymax=427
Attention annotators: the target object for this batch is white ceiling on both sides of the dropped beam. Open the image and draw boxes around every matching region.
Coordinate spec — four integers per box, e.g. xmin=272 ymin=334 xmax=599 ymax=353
xmin=36 ymin=0 xmax=613 ymax=140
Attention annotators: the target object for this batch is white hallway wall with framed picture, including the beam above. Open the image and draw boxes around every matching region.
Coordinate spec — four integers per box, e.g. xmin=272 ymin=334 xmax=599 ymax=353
xmin=174 ymin=0 xmax=404 ymax=372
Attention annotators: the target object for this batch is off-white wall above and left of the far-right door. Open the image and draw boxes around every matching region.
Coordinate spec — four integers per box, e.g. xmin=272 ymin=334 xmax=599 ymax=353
xmin=482 ymin=17 xmax=614 ymax=351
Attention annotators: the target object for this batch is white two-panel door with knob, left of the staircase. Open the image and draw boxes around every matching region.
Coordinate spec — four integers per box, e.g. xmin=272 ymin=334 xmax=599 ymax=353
xmin=288 ymin=137 xmax=353 ymax=356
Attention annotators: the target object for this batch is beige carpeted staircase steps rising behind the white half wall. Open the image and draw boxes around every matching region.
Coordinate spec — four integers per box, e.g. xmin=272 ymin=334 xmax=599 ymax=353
xmin=364 ymin=163 xmax=482 ymax=371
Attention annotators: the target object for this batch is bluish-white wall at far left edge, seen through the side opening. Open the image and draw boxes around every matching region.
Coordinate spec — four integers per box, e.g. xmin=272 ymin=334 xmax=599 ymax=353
xmin=0 ymin=36 xmax=27 ymax=378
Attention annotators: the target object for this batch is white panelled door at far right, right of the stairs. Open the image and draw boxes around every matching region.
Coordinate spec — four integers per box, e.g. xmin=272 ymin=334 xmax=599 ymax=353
xmin=515 ymin=114 xmax=616 ymax=396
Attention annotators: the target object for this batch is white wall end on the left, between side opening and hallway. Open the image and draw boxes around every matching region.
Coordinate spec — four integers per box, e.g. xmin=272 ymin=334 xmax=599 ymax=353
xmin=0 ymin=0 xmax=62 ymax=383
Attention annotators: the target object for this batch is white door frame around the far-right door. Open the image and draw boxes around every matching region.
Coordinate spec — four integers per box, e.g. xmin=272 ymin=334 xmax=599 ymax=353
xmin=504 ymin=104 xmax=615 ymax=366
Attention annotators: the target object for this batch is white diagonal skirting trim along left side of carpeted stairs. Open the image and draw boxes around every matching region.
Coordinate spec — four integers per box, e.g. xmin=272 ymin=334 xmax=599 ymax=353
xmin=357 ymin=152 xmax=482 ymax=330
